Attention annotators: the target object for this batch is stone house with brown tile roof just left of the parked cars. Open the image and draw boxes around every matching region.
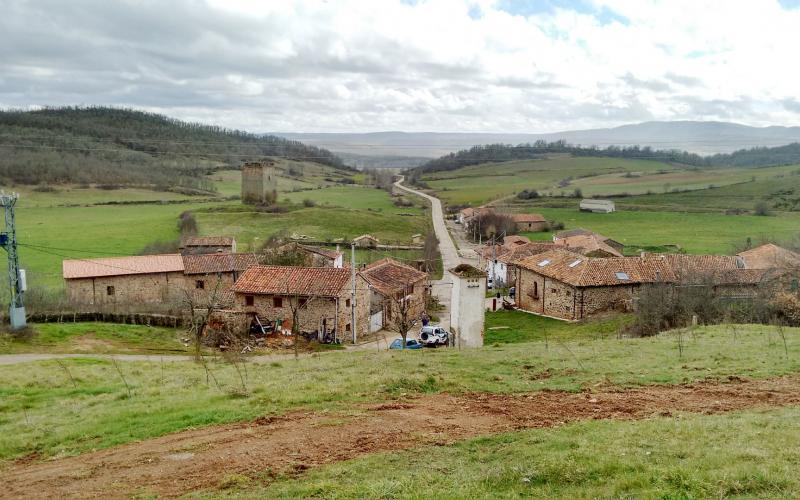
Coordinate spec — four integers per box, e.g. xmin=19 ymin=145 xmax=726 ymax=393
xmin=360 ymin=258 xmax=428 ymax=332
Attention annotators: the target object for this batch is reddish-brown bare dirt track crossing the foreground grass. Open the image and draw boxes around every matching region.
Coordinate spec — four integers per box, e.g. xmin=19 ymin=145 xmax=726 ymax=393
xmin=0 ymin=376 xmax=800 ymax=498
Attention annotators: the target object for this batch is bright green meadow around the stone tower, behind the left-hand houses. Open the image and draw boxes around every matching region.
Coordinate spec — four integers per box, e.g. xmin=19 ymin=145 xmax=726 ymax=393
xmin=7 ymin=160 xmax=429 ymax=288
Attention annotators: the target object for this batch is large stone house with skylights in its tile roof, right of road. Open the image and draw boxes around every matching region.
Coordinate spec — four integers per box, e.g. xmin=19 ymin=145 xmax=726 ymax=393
xmin=514 ymin=249 xmax=675 ymax=320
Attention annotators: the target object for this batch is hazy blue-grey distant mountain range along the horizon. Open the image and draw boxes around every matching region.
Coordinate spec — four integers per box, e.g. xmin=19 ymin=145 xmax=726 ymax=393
xmin=272 ymin=121 xmax=800 ymax=158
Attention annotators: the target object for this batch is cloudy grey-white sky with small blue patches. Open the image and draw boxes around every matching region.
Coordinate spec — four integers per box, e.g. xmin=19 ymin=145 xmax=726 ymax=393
xmin=0 ymin=0 xmax=800 ymax=132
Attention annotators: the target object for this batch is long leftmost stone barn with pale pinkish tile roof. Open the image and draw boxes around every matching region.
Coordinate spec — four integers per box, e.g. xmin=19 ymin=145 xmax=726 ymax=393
xmin=62 ymin=254 xmax=185 ymax=309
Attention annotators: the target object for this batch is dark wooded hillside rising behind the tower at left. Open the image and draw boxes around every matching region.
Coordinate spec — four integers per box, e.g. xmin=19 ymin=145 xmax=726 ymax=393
xmin=0 ymin=107 xmax=348 ymax=190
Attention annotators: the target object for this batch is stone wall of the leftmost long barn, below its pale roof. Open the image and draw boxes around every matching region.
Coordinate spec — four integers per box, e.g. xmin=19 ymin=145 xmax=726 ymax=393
xmin=65 ymin=272 xmax=185 ymax=309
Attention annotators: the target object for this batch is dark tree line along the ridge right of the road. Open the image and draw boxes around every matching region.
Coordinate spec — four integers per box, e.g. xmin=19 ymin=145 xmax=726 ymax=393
xmin=408 ymin=140 xmax=800 ymax=179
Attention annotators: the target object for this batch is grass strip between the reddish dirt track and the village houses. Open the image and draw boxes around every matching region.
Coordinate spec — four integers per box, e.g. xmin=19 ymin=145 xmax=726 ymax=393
xmin=0 ymin=322 xmax=800 ymax=460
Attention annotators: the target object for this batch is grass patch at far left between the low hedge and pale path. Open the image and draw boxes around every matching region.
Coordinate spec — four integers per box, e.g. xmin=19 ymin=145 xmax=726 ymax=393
xmin=0 ymin=323 xmax=186 ymax=354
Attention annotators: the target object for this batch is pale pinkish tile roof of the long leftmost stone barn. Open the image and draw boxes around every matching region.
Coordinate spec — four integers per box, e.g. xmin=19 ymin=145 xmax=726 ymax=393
xmin=62 ymin=254 xmax=183 ymax=279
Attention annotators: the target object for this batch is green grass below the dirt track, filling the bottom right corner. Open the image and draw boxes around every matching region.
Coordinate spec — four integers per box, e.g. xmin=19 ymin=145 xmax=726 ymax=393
xmin=245 ymin=407 xmax=800 ymax=499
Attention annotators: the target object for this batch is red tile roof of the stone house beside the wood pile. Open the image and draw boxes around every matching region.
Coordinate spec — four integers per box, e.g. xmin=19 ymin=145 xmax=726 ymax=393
xmin=233 ymin=266 xmax=350 ymax=297
